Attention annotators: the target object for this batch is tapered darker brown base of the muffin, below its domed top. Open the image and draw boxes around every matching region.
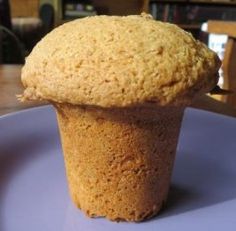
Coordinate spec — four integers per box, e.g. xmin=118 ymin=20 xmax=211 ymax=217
xmin=55 ymin=104 xmax=183 ymax=221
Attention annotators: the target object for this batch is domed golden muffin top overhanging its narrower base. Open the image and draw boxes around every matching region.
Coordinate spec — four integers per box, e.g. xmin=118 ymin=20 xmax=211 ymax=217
xmin=21 ymin=14 xmax=220 ymax=107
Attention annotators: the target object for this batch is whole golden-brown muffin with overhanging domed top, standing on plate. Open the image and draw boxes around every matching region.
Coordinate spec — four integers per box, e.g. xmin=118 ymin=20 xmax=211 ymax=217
xmin=21 ymin=14 xmax=220 ymax=221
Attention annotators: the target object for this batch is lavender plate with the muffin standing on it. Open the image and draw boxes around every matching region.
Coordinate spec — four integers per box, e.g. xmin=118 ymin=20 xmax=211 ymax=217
xmin=0 ymin=106 xmax=236 ymax=231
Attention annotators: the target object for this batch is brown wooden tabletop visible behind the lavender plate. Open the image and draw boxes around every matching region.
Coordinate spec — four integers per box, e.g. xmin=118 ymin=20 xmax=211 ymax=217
xmin=0 ymin=65 xmax=236 ymax=117
